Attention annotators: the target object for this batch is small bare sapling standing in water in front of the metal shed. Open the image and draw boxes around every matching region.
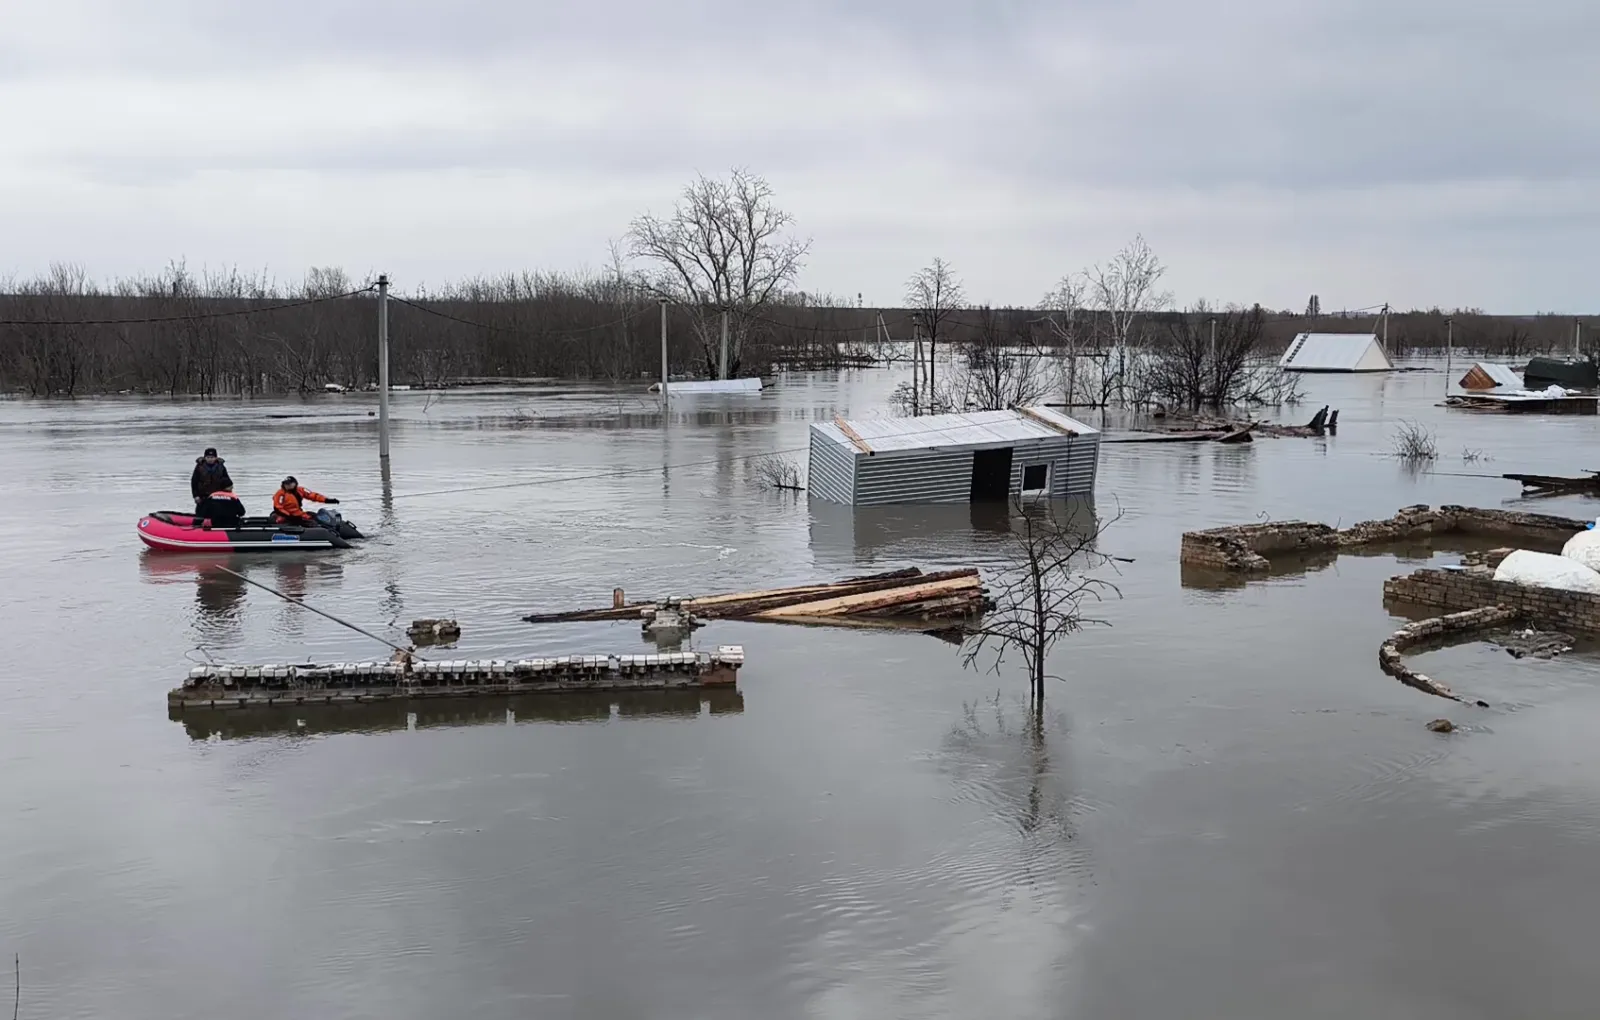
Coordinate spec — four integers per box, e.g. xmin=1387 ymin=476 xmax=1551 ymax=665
xmin=963 ymin=499 xmax=1122 ymax=705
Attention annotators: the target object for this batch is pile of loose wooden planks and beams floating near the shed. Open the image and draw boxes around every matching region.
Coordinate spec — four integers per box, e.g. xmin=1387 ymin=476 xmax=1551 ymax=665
xmin=523 ymin=568 xmax=990 ymax=628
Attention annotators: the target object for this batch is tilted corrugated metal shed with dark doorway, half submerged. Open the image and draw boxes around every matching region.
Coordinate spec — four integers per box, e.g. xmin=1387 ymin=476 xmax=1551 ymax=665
xmin=806 ymin=408 xmax=1101 ymax=507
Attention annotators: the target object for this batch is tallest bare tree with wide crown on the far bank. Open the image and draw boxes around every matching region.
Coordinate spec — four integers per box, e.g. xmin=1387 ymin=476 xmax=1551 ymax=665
xmin=627 ymin=168 xmax=811 ymax=380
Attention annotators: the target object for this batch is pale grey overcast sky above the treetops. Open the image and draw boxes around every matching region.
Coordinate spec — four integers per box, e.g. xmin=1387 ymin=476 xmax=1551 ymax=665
xmin=0 ymin=0 xmax=1600 ymax=312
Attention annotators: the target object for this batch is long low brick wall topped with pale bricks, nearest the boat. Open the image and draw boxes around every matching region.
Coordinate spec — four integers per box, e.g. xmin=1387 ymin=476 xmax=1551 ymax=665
xmin=166 ymin=644 xmax=744 ymax=710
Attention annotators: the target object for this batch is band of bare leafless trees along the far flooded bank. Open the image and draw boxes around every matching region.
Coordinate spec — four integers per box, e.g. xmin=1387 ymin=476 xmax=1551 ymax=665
xmin=0 ymin=169 xmax=1573 ymax=398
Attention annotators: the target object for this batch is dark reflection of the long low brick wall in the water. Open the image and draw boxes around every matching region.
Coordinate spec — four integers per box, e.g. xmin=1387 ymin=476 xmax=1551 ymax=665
xmin=168 ymin=691 xmax=744 ymax=740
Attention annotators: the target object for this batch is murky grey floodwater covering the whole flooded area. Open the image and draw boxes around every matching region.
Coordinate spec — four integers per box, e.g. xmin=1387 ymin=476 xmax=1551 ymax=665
xmin=0 ymin=369 xmax=1600 ymax=1020
